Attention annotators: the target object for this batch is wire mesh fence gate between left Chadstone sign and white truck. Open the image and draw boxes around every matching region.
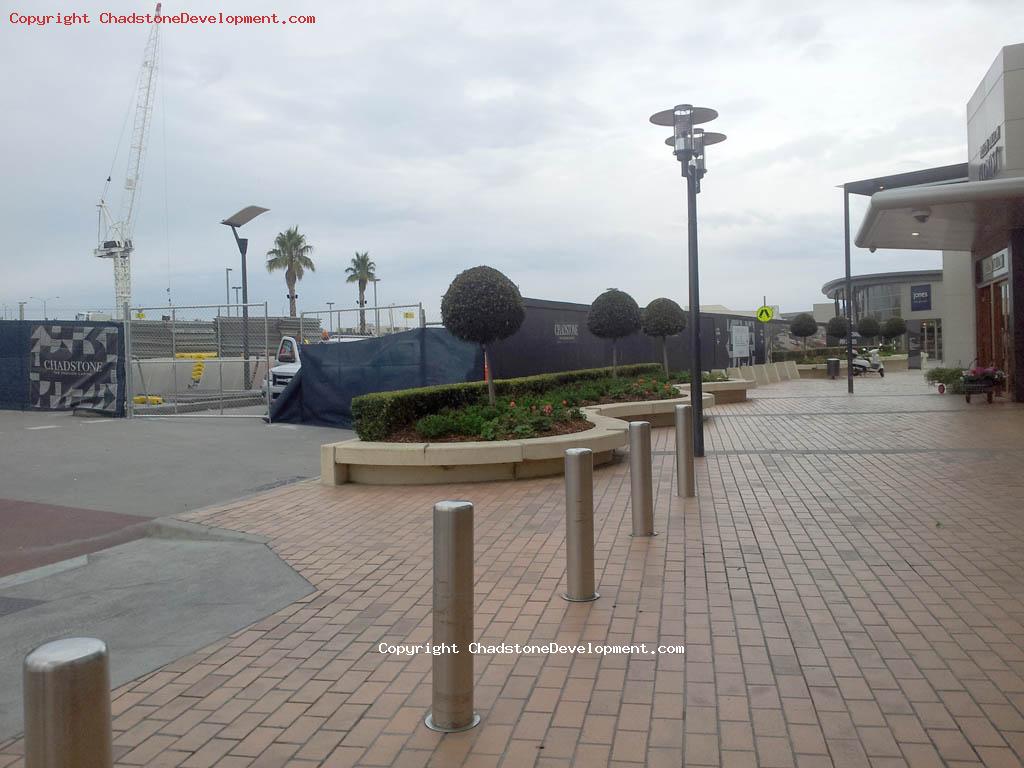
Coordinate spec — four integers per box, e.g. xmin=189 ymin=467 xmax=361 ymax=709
xmin=125 ymin=302 xmax=276 ymax=418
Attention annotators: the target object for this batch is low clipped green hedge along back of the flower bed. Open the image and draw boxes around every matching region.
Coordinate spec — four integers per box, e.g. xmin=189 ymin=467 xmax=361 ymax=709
xmin=352 ymin=362 xmax=662 ymax=440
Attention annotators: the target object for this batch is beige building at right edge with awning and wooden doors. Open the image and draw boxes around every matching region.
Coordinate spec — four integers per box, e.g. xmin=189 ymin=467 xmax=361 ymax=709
xmin=846 ymin=44 xmax=1024 ymax=400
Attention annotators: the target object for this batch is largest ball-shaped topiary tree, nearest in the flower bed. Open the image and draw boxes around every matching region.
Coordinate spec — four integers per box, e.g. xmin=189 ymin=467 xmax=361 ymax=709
xmin=441 ymin=266 xmax=526 ymax=406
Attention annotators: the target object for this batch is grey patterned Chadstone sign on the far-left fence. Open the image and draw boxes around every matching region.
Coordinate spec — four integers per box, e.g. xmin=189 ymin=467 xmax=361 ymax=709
xmin=28 ymin=323 xmax=124 ymax=416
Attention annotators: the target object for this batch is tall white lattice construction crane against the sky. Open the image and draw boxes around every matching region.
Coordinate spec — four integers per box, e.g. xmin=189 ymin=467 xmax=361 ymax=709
xmin=93 ymin=3 xmax=161 ymax=318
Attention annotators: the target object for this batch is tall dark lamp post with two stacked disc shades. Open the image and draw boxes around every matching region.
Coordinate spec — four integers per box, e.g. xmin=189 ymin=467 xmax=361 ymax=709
xmin=650 ymin=104 xmax=725 ymax=456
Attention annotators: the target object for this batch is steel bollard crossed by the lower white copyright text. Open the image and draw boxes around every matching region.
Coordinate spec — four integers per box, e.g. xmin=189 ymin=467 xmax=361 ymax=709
xmin=424 ymin=502 xmax=480 ymax=733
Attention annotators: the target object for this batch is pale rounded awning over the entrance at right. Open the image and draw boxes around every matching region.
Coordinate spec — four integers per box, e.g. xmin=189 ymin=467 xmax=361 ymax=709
xmin=855 ymin=177 xmax=1024 ymax=251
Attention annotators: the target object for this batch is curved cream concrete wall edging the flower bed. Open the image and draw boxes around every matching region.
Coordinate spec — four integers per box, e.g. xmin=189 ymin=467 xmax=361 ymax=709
xmin=321 ymin=392 xmax=716 ymax=485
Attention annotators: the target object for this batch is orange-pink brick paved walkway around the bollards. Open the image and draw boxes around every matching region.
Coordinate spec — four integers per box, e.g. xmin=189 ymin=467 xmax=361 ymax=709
xmin=0 ymin=374 xmax=1024 ymax=767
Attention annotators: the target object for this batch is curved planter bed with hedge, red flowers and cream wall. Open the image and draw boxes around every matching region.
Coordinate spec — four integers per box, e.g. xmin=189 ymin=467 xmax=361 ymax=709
xmin=321 ymin=366 xmax=729 ymax=485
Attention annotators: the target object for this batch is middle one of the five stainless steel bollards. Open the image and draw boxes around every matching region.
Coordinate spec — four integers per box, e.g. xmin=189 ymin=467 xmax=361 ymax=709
xmin=562 ymin=449 xmax=600 ymax=603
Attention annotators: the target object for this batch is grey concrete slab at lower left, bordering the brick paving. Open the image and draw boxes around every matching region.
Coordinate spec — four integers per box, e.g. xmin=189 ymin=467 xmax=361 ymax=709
xmin=0 ymin=531 xmax=312 ymax=739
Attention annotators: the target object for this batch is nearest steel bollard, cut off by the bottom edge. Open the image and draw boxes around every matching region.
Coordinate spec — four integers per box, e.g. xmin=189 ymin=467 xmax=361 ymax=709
xmin=24 ymin=637 xmax=114 ymax=768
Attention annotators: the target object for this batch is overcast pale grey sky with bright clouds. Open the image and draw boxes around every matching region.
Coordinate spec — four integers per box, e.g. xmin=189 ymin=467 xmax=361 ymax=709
xmin=0 ymin=0 xmax=1024 ymax=319
